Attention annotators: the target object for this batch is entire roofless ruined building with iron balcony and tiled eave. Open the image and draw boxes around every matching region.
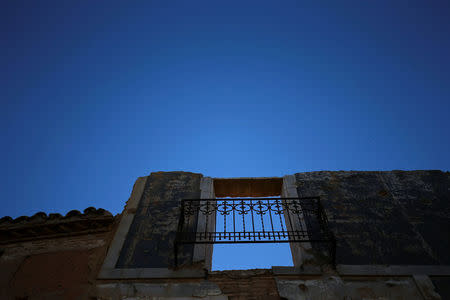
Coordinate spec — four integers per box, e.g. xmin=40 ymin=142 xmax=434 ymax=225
xmin=0 ymin=171 xmax=450 ymax=299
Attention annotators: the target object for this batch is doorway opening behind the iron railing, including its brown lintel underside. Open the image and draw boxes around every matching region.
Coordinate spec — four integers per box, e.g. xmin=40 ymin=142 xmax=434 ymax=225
xmin=212 ymin=178 xmax=293 ymax=271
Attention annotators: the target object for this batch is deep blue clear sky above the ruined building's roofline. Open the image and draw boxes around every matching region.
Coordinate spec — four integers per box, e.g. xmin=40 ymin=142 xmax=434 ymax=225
xmin=0 ymin=0 xmax=450 ymax=270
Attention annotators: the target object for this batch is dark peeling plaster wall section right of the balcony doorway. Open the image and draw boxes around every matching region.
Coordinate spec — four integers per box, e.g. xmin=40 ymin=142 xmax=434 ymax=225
xmin=295 ymin=171 xmax=450 ymax=265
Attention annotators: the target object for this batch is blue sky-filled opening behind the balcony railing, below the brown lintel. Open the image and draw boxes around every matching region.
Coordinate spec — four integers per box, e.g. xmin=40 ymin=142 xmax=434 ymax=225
xmin=212 ymin=196 xmax=293 ymax=271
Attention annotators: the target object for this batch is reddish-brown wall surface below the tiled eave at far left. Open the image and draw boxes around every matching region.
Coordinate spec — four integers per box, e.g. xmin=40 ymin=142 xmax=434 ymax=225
xmin=0 ymin=232 xmax=112 ymax=300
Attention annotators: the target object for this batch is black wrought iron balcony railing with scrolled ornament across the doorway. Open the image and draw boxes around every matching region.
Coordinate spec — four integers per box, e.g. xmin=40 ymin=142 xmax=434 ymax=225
xmin=175 ymin=197 xmax=335 ymax=264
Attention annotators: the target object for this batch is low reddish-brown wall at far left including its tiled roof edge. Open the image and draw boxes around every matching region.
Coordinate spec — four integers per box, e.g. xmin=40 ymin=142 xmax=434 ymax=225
xmin=0 ymin=207 xmax=116 ymax=299
